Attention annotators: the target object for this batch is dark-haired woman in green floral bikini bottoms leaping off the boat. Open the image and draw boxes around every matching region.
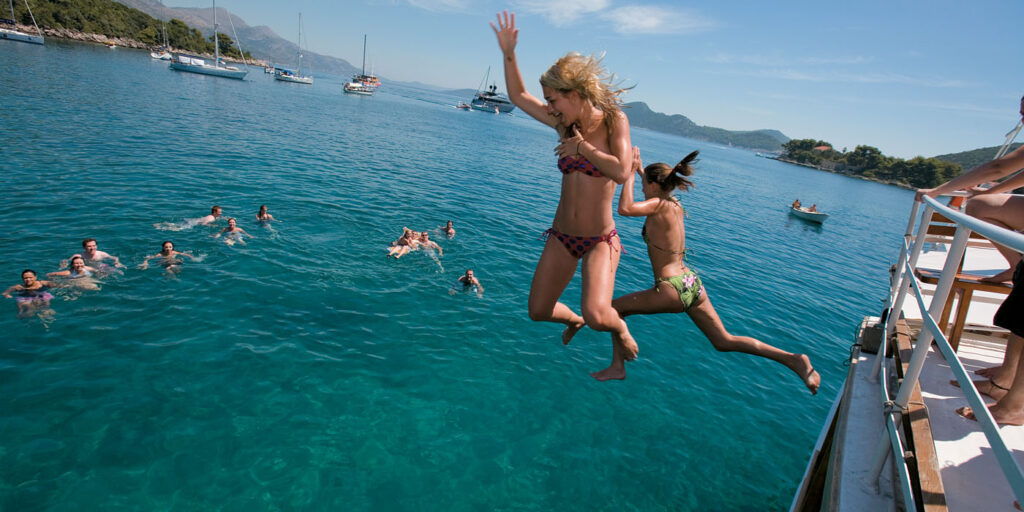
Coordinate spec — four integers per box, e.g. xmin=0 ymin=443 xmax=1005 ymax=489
xmin=591 ymin=148 xmax=821 ymax=394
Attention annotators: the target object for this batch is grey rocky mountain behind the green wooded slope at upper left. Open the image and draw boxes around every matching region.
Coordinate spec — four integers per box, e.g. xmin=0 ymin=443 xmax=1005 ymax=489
xmin=116 ymin=0 xmax=359 ymax=78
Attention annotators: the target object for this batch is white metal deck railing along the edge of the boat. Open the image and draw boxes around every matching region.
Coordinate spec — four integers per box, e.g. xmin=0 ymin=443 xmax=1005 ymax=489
xmin=870 ymin=197 xmax=1024 ymax=510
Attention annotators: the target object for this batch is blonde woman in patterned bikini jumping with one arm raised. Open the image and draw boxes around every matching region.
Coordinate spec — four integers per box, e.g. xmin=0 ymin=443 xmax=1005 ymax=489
xmin=490 ymin=11 xmax=637 ymax=359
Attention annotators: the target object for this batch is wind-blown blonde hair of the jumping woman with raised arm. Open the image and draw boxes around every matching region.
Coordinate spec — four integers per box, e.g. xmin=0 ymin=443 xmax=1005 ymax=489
xmin=541 ymin=51 xmax=631 ymax=131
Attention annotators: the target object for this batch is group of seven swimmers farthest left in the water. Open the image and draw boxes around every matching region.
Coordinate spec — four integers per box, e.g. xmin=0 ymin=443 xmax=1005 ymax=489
xmin=3 ymin=205 xmax=273 ymax=319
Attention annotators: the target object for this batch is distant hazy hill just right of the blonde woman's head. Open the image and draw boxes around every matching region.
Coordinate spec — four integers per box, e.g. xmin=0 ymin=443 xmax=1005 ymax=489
xmin=623 ymin=101 xmax=790 ymax=152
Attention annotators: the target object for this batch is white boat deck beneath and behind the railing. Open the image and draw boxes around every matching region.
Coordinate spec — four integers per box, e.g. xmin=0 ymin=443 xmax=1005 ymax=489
xmin=831 ymin=246 xmax=1024 ymax=511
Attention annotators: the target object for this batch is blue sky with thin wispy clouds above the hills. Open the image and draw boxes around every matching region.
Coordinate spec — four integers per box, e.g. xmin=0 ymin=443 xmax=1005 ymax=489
xmin=172 ymin=0 xmax=1024 ymax=158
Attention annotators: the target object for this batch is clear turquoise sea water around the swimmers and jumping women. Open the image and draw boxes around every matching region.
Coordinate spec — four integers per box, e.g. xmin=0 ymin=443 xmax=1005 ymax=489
xmin=0 ymin=40 xmax=911 ymax=511
